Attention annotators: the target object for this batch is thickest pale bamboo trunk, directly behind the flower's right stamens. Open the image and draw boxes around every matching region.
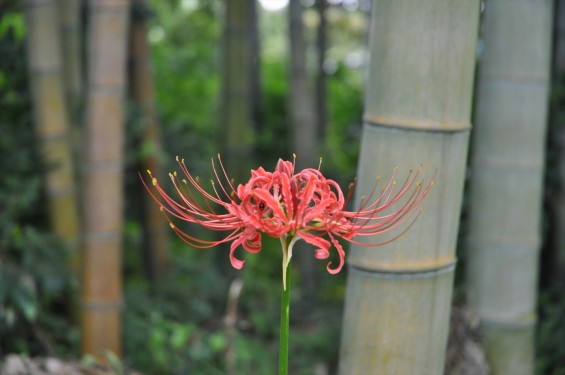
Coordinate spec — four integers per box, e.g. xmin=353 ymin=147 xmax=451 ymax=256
xmin=339 ymin=0 xmax=480 ymax=375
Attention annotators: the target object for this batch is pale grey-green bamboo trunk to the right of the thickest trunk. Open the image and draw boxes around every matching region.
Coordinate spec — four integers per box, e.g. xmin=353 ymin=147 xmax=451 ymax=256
xmin=467 ymin=0 xmax=552 ymax=374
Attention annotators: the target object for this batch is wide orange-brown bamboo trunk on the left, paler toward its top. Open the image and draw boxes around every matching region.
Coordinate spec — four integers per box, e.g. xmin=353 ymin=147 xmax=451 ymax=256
xmin=82 ymin=0 xmax=129 ymax=359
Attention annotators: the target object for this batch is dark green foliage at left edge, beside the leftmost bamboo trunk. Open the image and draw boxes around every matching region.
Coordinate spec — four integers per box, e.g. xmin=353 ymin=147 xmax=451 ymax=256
xmin=0 ymin=6 xmax=76 ymax=354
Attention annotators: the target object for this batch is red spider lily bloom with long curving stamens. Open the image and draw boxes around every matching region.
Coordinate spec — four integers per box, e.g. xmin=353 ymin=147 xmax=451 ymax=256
xmin=142 ymin=155 xmax=433 ymax=275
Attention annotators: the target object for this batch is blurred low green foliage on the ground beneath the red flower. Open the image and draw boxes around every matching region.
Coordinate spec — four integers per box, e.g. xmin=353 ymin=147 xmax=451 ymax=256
xmin=124 ymin=239 xmax=343 ymax=375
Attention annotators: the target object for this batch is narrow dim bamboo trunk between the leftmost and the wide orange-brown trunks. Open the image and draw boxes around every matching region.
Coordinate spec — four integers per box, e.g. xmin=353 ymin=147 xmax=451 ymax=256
xmin=58 ymin=0 xmax=83 ymax=125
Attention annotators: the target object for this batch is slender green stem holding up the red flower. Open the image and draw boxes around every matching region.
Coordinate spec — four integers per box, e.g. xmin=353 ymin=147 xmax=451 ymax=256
xmin=279 ymin=238 xmax=294 ymax=375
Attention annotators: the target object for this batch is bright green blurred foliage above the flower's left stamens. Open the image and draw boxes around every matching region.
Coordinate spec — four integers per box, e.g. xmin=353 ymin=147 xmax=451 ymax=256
xmin=145 ymin=1 xmax=221 ymax=166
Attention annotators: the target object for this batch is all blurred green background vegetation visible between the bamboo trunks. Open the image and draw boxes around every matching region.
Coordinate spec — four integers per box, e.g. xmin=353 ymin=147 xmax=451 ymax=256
xmin=0 ymin=0 xmax=565 ymax=375
